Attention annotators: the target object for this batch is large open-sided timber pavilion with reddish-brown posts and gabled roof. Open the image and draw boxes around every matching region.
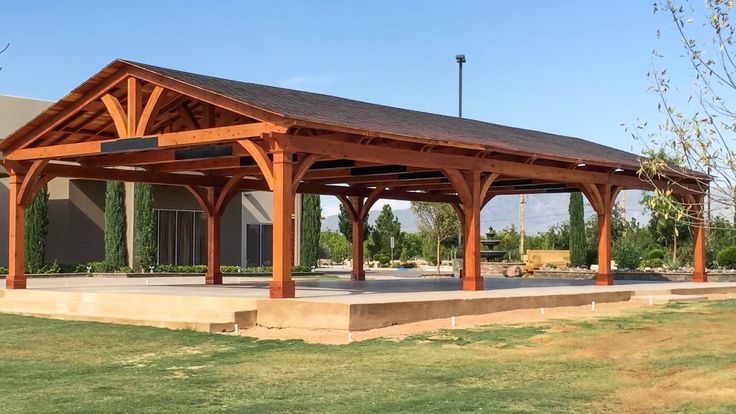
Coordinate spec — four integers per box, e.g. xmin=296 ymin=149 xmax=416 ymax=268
xmin=0 ymin=60 xmax=707 ymax=298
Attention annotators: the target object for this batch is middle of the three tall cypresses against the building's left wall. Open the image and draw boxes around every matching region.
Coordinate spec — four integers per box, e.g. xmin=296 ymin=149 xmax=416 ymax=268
xmin=105 ymin=181 xmax=128 ymax=270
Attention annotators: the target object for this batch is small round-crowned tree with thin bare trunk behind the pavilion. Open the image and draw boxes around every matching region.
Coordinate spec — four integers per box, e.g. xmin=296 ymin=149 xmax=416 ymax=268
xmin=411 ymin=201 xmax=460 ymax=274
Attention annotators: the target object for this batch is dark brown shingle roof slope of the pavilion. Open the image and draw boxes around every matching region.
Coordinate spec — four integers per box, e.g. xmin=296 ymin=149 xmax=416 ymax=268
xmin=127 ymin=61 xmax=639 ymax=168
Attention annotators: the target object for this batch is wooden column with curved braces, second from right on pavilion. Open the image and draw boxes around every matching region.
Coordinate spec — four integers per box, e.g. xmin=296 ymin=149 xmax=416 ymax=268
xmin=580 ymin=184 xmax=620 ymax=286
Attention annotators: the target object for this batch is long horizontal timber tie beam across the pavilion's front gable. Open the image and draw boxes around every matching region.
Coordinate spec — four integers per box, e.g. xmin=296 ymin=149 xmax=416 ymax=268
xmin=6 ymin=123 xmax=280 ymax=161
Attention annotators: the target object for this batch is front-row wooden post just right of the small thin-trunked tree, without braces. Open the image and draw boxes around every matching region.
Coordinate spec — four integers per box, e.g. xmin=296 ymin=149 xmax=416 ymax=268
xmin=463 ymin=171 xmax=483 ymax=290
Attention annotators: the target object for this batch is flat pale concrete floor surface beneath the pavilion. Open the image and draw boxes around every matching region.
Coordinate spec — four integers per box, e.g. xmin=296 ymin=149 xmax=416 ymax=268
xmin=12 ymin=274 xmax=736 ymax=303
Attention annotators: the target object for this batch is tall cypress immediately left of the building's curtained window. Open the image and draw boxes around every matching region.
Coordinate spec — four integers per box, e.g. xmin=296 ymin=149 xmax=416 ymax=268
xmin=133 ymin=184 xmax=156 ymax=272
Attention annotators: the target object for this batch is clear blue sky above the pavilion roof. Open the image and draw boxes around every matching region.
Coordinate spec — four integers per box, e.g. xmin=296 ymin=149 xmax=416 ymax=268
xmin=0 ymin=0 xmax=688 ymax=218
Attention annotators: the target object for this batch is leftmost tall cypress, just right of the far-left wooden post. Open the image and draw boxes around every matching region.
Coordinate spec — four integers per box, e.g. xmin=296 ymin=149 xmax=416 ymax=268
xmin=24 ymin=186 xmax=49 ymax=273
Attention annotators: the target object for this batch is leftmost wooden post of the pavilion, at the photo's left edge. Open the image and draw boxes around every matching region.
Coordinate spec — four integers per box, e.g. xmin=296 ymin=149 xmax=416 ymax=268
xmin=5 ymin=173 xmax=26 ymax=289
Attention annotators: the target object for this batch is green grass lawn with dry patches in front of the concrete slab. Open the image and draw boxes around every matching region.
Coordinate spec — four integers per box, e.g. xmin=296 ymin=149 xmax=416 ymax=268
xmin=0 ymin=301 xmax=736 ymax=413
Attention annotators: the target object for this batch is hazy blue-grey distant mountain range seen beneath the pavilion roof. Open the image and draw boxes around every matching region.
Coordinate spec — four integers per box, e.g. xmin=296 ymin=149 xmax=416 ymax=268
xmin=322 ymin=190 xmax=649 ymax=235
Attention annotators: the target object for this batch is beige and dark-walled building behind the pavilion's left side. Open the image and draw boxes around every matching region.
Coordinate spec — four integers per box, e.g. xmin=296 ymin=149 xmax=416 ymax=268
xmin=0 ymin=95 xmax=300 ymax=266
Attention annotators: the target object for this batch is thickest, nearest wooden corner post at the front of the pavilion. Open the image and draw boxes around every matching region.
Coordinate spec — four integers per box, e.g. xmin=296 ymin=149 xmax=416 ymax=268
xmin=270 ymin=148 xmax=296 ymax=299
